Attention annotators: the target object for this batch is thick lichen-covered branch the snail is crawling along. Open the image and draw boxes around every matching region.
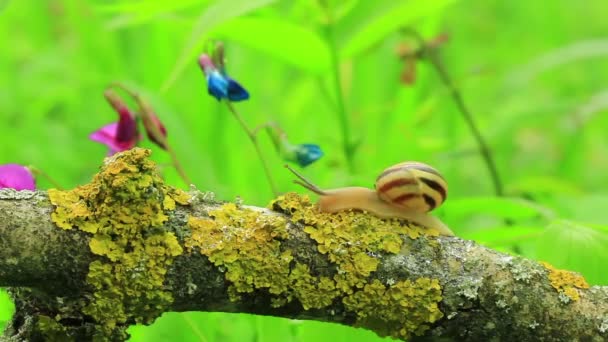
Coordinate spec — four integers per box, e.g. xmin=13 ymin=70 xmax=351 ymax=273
xmin=0 ymin=149 xmax=608 ymax=341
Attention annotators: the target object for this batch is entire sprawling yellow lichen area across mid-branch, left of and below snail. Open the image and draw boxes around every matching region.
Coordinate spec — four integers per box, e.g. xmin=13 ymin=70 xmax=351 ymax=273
xmin=185 ymin=194 xmax=442 ymax=338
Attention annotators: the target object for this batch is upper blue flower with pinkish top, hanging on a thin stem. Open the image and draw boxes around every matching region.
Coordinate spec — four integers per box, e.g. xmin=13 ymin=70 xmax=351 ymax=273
xmin=198 ymin=54 xmax=249 ymax=101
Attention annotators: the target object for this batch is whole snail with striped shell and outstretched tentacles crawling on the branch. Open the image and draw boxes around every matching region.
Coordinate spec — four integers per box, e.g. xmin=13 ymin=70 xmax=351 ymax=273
xmin=285 ymin=161 xmax=454 ymax=236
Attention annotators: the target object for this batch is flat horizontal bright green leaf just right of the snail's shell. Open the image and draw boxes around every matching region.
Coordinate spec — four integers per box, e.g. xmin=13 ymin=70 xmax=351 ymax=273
xmin=442 ymin=196 xmax=554 ymax=220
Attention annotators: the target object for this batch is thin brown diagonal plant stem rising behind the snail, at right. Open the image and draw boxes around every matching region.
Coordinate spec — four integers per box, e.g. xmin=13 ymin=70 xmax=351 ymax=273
xmin=407 ymin=29 xmax=504 ymax=196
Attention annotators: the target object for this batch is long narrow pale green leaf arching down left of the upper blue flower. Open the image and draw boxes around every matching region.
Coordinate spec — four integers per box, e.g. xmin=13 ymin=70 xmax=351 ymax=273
xmin=161 ymin=0 xmax=276 ymax=92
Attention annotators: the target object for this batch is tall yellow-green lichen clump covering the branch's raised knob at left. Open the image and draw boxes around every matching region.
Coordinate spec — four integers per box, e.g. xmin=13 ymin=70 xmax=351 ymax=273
xmin=49 ymin=148 xmax=189 ymax=335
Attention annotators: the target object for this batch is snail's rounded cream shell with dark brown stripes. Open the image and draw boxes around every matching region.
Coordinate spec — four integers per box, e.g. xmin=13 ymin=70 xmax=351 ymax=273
xmin=376 ymin=162 xmax=448 ymax=213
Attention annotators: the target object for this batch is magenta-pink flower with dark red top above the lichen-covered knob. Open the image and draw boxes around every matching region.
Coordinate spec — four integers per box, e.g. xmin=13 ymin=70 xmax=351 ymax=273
xmin=89 ymin=91 xmax=141 ymax=155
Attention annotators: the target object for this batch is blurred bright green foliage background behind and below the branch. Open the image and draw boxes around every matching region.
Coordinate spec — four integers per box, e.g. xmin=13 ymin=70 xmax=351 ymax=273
xmin=0 ymin=0 xmax=608 ymax=341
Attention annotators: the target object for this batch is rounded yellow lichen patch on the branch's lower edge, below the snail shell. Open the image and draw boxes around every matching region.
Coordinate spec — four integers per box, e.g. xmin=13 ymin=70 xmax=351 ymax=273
xmin=343 ymin=278 xmax=443 ymax=339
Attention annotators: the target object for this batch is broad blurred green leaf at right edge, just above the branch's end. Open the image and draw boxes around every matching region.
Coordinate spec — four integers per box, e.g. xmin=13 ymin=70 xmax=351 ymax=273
xmin=536 ymin=220 xmax=608 ymax=285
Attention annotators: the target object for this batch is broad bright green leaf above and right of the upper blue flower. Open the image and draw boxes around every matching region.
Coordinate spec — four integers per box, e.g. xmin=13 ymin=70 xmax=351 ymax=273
xmin=212 ymin=18 xmax=330 ymax=75
